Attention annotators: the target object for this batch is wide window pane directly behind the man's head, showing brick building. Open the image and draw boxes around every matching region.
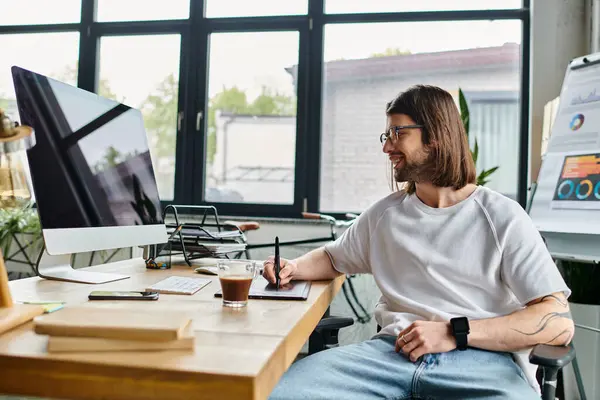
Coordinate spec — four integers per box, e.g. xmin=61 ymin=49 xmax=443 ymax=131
xmin=320 ymin=21 xmax=521 ymax=212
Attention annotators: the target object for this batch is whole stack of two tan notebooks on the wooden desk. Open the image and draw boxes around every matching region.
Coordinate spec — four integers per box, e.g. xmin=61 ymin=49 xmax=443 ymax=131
xmin=34 ymin=307 xmax=195 ymax=352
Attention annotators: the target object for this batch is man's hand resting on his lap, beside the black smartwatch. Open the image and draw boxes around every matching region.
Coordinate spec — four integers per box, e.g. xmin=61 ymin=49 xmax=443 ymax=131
xmin=396 ymin=321 xmax=456 ymax=362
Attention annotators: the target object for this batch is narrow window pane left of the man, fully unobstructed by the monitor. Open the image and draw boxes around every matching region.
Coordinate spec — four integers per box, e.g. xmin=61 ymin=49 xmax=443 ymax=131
xmin=205 ymin=32 xmax=298 ymax=204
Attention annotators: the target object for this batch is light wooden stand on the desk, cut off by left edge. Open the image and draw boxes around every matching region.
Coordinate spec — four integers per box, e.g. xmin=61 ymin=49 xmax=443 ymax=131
xmin=0 ymin=252 xmax=44 ymax=334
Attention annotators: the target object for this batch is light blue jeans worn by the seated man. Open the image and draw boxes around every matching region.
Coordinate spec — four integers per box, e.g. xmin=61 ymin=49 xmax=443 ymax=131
xmin=270 ymin=336 xmax=540 ymax=400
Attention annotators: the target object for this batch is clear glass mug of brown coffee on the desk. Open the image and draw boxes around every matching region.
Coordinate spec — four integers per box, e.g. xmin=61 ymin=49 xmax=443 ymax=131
xmin=217 ymin=260 xmax=259 ymax=307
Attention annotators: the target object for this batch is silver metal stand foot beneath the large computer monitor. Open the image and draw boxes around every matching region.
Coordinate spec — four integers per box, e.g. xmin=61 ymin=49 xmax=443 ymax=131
xmin=37 ymin=248 xmax=129 ymax=284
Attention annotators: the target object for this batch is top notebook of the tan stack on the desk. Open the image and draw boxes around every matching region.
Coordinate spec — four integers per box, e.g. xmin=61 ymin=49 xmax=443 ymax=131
xmin=34 ymin=306 xmax=191 ymax=341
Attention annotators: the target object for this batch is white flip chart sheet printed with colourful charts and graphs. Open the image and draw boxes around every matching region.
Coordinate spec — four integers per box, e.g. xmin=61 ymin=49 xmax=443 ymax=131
xmin=529 ymin=58 xmax=600 ymax=234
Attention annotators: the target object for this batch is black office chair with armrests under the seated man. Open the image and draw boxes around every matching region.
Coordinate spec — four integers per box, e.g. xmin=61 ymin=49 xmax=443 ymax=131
xmin=308 ymin=316 xmax=585 ymax=400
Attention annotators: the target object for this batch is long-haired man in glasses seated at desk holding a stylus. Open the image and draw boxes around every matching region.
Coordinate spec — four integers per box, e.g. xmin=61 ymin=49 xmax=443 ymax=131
xmin=264 ymin=86 xmax=574 ymax=400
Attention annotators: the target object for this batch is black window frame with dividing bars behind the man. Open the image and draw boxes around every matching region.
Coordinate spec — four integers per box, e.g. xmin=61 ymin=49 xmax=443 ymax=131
xmin=0 ymin=0 xmax=531 ymax=218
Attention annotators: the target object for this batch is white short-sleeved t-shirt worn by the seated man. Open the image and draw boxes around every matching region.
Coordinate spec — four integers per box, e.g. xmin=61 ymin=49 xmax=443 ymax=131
xmin=325 ymin=186 xmax=571 ymax=388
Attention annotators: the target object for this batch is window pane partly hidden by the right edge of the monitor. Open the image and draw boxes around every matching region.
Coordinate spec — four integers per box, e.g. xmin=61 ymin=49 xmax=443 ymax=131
xmin=98 ymin=35 xmax=181 ymax=200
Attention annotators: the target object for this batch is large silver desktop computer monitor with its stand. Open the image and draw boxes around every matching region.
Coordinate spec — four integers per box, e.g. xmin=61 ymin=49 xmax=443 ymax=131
xmin=12 ymin=67 xmax=167 ymax=283
